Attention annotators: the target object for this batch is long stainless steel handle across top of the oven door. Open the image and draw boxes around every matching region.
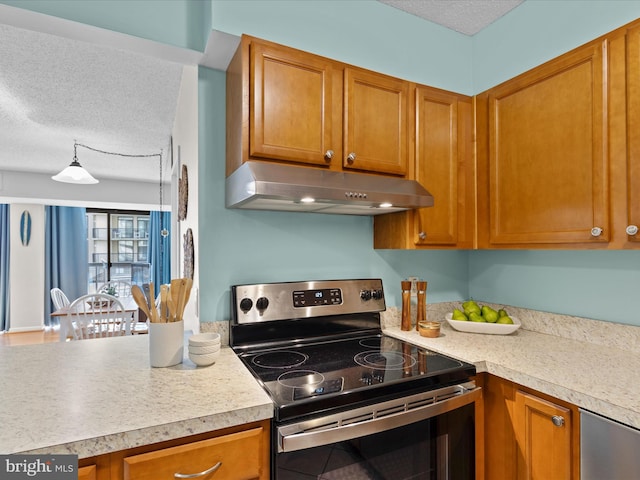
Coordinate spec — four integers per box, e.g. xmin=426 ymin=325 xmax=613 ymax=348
xmin=277 ymin=382 xmax=482 ymax=453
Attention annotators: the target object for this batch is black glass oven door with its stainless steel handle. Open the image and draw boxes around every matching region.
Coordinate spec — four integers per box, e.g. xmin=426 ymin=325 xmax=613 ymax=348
xmin=273 ymin=382 xmax=480 ymax=480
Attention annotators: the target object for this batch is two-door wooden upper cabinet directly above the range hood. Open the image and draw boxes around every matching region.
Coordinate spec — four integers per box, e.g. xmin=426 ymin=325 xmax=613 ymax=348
xmin=226 ymin=35 xmax=413 ymax=177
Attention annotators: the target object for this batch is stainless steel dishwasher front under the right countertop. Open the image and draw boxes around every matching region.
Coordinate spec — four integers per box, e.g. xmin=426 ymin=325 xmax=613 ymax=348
xmin=580 ymin=409 xmax=640 ymax=480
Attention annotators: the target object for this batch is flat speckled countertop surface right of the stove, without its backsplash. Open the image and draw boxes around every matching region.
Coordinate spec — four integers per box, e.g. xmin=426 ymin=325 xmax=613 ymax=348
xmin=385 ymin=322 xmax=640 ymax=428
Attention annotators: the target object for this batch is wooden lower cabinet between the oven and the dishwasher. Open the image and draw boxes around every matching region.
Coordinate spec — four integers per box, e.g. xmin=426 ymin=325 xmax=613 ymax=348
xmin=480 ymin=374 xmax=580 ymax=480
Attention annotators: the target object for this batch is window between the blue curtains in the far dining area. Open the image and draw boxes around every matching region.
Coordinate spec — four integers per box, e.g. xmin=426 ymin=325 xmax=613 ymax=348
xmin=87 ymin=209 xmax=150 ymax=293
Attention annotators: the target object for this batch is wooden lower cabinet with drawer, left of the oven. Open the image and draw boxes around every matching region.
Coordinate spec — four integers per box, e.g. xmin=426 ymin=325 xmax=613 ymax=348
xmin=78 ymin=420 xmax=271 ymax=480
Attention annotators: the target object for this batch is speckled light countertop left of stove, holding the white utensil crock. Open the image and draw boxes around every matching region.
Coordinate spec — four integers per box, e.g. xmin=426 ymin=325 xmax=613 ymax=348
xmin=0 ymin=335 xmax=273 ymax=458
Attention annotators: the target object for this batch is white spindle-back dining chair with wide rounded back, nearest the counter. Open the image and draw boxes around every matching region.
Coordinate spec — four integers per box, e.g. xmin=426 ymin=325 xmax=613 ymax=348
xmin=66 ymin=293 xmax=137 ymax=340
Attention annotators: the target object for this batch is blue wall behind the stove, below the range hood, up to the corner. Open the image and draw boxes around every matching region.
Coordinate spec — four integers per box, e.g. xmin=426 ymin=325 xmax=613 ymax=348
xmin=198 ymin=68 xmax=467 ymax=321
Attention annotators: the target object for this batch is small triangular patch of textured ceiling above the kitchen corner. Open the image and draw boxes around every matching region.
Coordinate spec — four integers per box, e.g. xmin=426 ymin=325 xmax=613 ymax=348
xmin=379 ymin=0 xmax=524 ymax=35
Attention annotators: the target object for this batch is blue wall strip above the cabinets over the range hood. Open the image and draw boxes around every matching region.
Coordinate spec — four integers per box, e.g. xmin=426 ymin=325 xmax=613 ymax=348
xmin=211 ymin=0 xmax=473 ymax=95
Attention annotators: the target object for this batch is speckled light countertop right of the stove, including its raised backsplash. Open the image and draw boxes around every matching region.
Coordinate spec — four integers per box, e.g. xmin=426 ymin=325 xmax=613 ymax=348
xmin=383 ymin=305 xmax=640 ymax=434
